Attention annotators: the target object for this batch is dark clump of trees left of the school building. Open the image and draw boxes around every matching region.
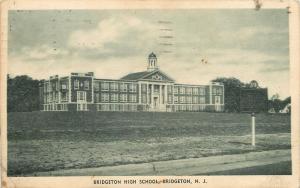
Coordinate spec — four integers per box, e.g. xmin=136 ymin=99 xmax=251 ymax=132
xmin=7 ymin=75 xmax=39 ymax=112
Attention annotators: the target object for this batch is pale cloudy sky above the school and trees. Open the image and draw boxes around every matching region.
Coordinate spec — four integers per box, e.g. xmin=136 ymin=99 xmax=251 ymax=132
xmin=8 ymin=9 xmax=290 ymax=99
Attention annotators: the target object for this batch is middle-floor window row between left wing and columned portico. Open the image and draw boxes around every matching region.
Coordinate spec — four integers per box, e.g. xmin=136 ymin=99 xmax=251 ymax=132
xmin=95 ymin=93 xmax=137 ymax=102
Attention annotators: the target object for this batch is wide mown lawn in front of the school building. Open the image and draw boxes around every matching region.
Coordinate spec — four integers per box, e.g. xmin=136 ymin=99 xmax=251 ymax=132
xmin=8 ymin=112 xmax=291 ymax=176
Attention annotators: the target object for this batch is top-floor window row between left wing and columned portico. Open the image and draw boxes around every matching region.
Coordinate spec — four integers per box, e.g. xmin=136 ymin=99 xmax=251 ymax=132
xmin=94 ymin=82 xmax=137 ymax=93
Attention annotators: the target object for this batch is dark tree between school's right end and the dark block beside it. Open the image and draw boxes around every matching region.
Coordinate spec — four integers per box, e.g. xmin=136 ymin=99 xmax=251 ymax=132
xmin=212 ymin=77 xmax=249 ymax=112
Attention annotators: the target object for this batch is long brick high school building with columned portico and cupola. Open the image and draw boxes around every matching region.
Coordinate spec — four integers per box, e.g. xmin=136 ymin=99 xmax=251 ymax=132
xmin=40 ymin=53 xmax=224 ymax=112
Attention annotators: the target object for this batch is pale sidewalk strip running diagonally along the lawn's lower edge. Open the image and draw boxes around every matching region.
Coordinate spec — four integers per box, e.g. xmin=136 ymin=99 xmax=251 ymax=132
xmin=32 ymin=150 xmax=291 ymax=176
